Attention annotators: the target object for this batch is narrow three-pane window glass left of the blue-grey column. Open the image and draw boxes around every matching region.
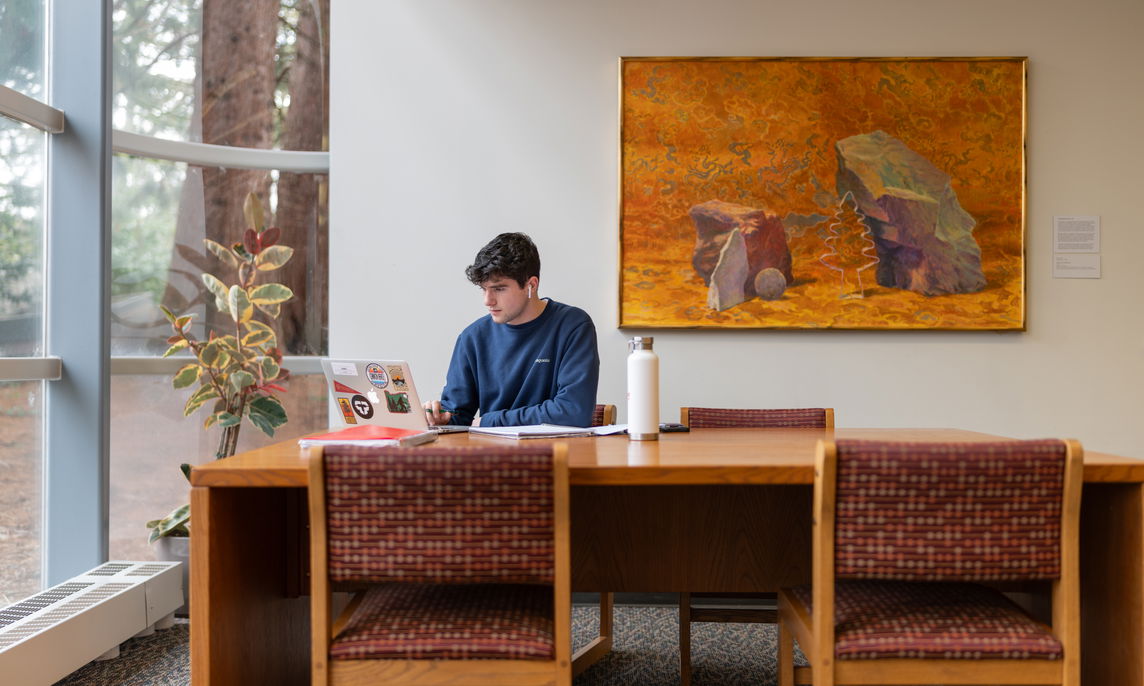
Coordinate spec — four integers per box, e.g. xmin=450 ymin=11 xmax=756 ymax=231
xmin=0 ymin=0 xmax=48 ymax=606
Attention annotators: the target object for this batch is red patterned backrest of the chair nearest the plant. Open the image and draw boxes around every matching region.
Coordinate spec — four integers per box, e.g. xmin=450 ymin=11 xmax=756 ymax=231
xmin=325 ymin=445 xmax=555 ymax=584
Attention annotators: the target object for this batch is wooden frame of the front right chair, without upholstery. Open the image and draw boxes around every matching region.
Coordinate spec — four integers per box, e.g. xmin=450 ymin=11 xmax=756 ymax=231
xmin=778 ymin=439 xmax=1083 ymax=686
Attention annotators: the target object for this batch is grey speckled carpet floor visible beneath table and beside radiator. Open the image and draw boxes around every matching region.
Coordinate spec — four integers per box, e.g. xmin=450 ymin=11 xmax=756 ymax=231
xmin=56 ymin=606 xmax=776 ymax=686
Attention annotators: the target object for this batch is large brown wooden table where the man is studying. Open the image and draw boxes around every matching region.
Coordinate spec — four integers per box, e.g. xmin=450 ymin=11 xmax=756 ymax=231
xmin=191 ymin=429 xmax=1144 ymax=686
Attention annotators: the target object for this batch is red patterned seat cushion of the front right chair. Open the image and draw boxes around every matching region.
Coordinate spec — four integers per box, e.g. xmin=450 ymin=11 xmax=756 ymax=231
xmin=789 ymin=581 xmax=1063 ymax=660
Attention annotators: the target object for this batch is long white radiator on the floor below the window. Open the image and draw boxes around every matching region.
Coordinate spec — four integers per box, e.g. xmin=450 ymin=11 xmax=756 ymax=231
xmin=0 ymin=560 xmax=183 ymax=686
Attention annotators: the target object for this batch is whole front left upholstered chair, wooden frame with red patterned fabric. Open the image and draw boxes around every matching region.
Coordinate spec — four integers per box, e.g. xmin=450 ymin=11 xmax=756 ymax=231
xmin=309 ymin=444 xmax=572 ymax=686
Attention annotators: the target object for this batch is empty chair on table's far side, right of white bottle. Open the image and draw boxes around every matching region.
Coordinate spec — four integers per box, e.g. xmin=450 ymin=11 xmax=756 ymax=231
xmin=680 ymin=407 xmax=834 ymax=686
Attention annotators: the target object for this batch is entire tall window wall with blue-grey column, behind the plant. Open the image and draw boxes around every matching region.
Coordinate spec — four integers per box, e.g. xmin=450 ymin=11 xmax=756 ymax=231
xmin=0 ymin=0 xmax=329 ymax=604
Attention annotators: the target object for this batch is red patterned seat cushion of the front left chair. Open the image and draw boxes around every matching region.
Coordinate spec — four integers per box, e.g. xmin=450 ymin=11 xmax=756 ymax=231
xmin=329 ymin=583 xmax=555 ymax=660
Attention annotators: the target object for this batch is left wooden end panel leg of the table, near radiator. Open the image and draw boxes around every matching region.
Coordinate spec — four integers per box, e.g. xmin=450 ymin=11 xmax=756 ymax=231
xmin=190 ymin=487 xmax=310 ymax=686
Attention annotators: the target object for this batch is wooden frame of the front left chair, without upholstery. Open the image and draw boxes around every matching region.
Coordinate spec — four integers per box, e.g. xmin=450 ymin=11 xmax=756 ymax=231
xmin=309 ymin=444 xmax=572 ymax=686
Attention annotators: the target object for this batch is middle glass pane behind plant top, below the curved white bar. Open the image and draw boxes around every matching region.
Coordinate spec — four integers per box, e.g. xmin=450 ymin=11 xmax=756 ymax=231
xmin=111 ymin=155 xmax=327 ymax=354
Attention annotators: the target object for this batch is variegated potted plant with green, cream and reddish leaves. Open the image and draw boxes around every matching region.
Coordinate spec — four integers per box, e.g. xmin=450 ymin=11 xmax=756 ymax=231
xmin=146 ymin=193 xmax=294 ymax=588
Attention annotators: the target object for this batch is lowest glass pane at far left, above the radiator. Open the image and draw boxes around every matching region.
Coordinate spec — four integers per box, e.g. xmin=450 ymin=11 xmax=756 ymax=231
xmin=0 ymin=381 xmax=43 ymax=607
